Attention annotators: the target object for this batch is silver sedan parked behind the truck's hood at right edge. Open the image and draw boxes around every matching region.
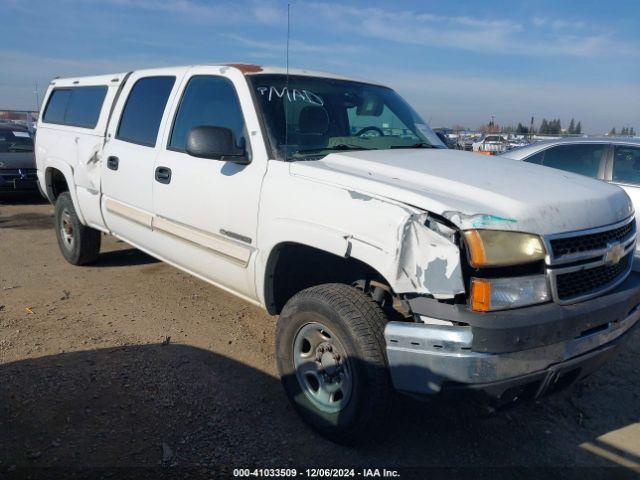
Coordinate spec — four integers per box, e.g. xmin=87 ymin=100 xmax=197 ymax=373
xmin=502 ymin=137 xmax=640 ymax=257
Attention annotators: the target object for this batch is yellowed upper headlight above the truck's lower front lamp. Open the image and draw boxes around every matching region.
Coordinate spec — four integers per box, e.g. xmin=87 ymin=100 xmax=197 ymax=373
xmin=464 ymin=230 xmax=546 ymax=268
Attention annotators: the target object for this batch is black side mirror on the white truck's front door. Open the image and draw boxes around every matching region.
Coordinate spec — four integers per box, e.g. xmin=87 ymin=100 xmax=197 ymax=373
xmin=186 ymin=125 xmax=249 ymax=164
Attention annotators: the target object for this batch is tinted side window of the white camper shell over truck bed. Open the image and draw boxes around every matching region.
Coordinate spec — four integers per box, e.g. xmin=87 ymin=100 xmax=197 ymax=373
xmin=43 ymin=86 xmax=107 ymax=128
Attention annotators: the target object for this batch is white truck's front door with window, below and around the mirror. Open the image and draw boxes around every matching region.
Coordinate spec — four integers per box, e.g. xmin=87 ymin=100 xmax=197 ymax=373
xmin=153 ymin=66 xmax=267 ymax=298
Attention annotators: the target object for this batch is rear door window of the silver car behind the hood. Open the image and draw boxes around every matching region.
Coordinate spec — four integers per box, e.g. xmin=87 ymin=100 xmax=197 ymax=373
xmin=542 ymin=143 xmax=608 ymax=178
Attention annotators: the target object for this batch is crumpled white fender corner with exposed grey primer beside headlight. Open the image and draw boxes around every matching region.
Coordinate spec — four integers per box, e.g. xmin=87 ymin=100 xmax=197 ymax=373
xmin=396 ymin=213 xmax=464 ymax=298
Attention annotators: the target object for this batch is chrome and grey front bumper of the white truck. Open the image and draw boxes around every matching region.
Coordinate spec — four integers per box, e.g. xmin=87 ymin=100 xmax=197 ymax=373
xmin=385 ymin=273 xmax=640 ymax=396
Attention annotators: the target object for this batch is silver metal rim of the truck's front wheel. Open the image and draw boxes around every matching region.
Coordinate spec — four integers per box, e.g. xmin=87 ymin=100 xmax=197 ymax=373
xmin=293 ymin=322 xmax=353 ymax=413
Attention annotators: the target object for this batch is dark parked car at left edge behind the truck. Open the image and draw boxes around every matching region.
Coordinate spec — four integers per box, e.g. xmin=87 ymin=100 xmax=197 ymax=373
xmin=0 ymin=123 xmax=39 ymax=194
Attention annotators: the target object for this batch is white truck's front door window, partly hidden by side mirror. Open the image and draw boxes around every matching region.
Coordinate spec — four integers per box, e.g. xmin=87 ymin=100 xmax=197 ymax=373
xmin=169 ymin=76 xmax=246 ymax=151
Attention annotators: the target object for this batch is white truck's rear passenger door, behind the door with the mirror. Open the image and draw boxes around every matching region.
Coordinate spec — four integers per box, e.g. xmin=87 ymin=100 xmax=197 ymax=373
xmin=101 ymin=68 xmax=186 ymax=250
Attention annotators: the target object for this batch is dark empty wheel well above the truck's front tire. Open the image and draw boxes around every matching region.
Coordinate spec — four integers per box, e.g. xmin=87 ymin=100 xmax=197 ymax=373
xmin=265 ymin=243 xmax=388 ymax=315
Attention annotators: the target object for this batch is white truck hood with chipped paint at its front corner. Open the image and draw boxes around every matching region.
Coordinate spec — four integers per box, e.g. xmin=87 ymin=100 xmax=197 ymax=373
xmin=290 ymin=149 xmax=633 ymax=235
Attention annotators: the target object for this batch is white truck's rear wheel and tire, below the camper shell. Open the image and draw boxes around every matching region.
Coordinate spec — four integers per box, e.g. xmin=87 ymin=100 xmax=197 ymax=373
xmin=54 ymin=192 xmax=100 ymax=265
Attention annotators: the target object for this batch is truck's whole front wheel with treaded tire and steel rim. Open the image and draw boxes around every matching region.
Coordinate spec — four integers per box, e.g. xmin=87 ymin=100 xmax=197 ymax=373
xmin=276 ymin=284 xmax=393 ymax=444
